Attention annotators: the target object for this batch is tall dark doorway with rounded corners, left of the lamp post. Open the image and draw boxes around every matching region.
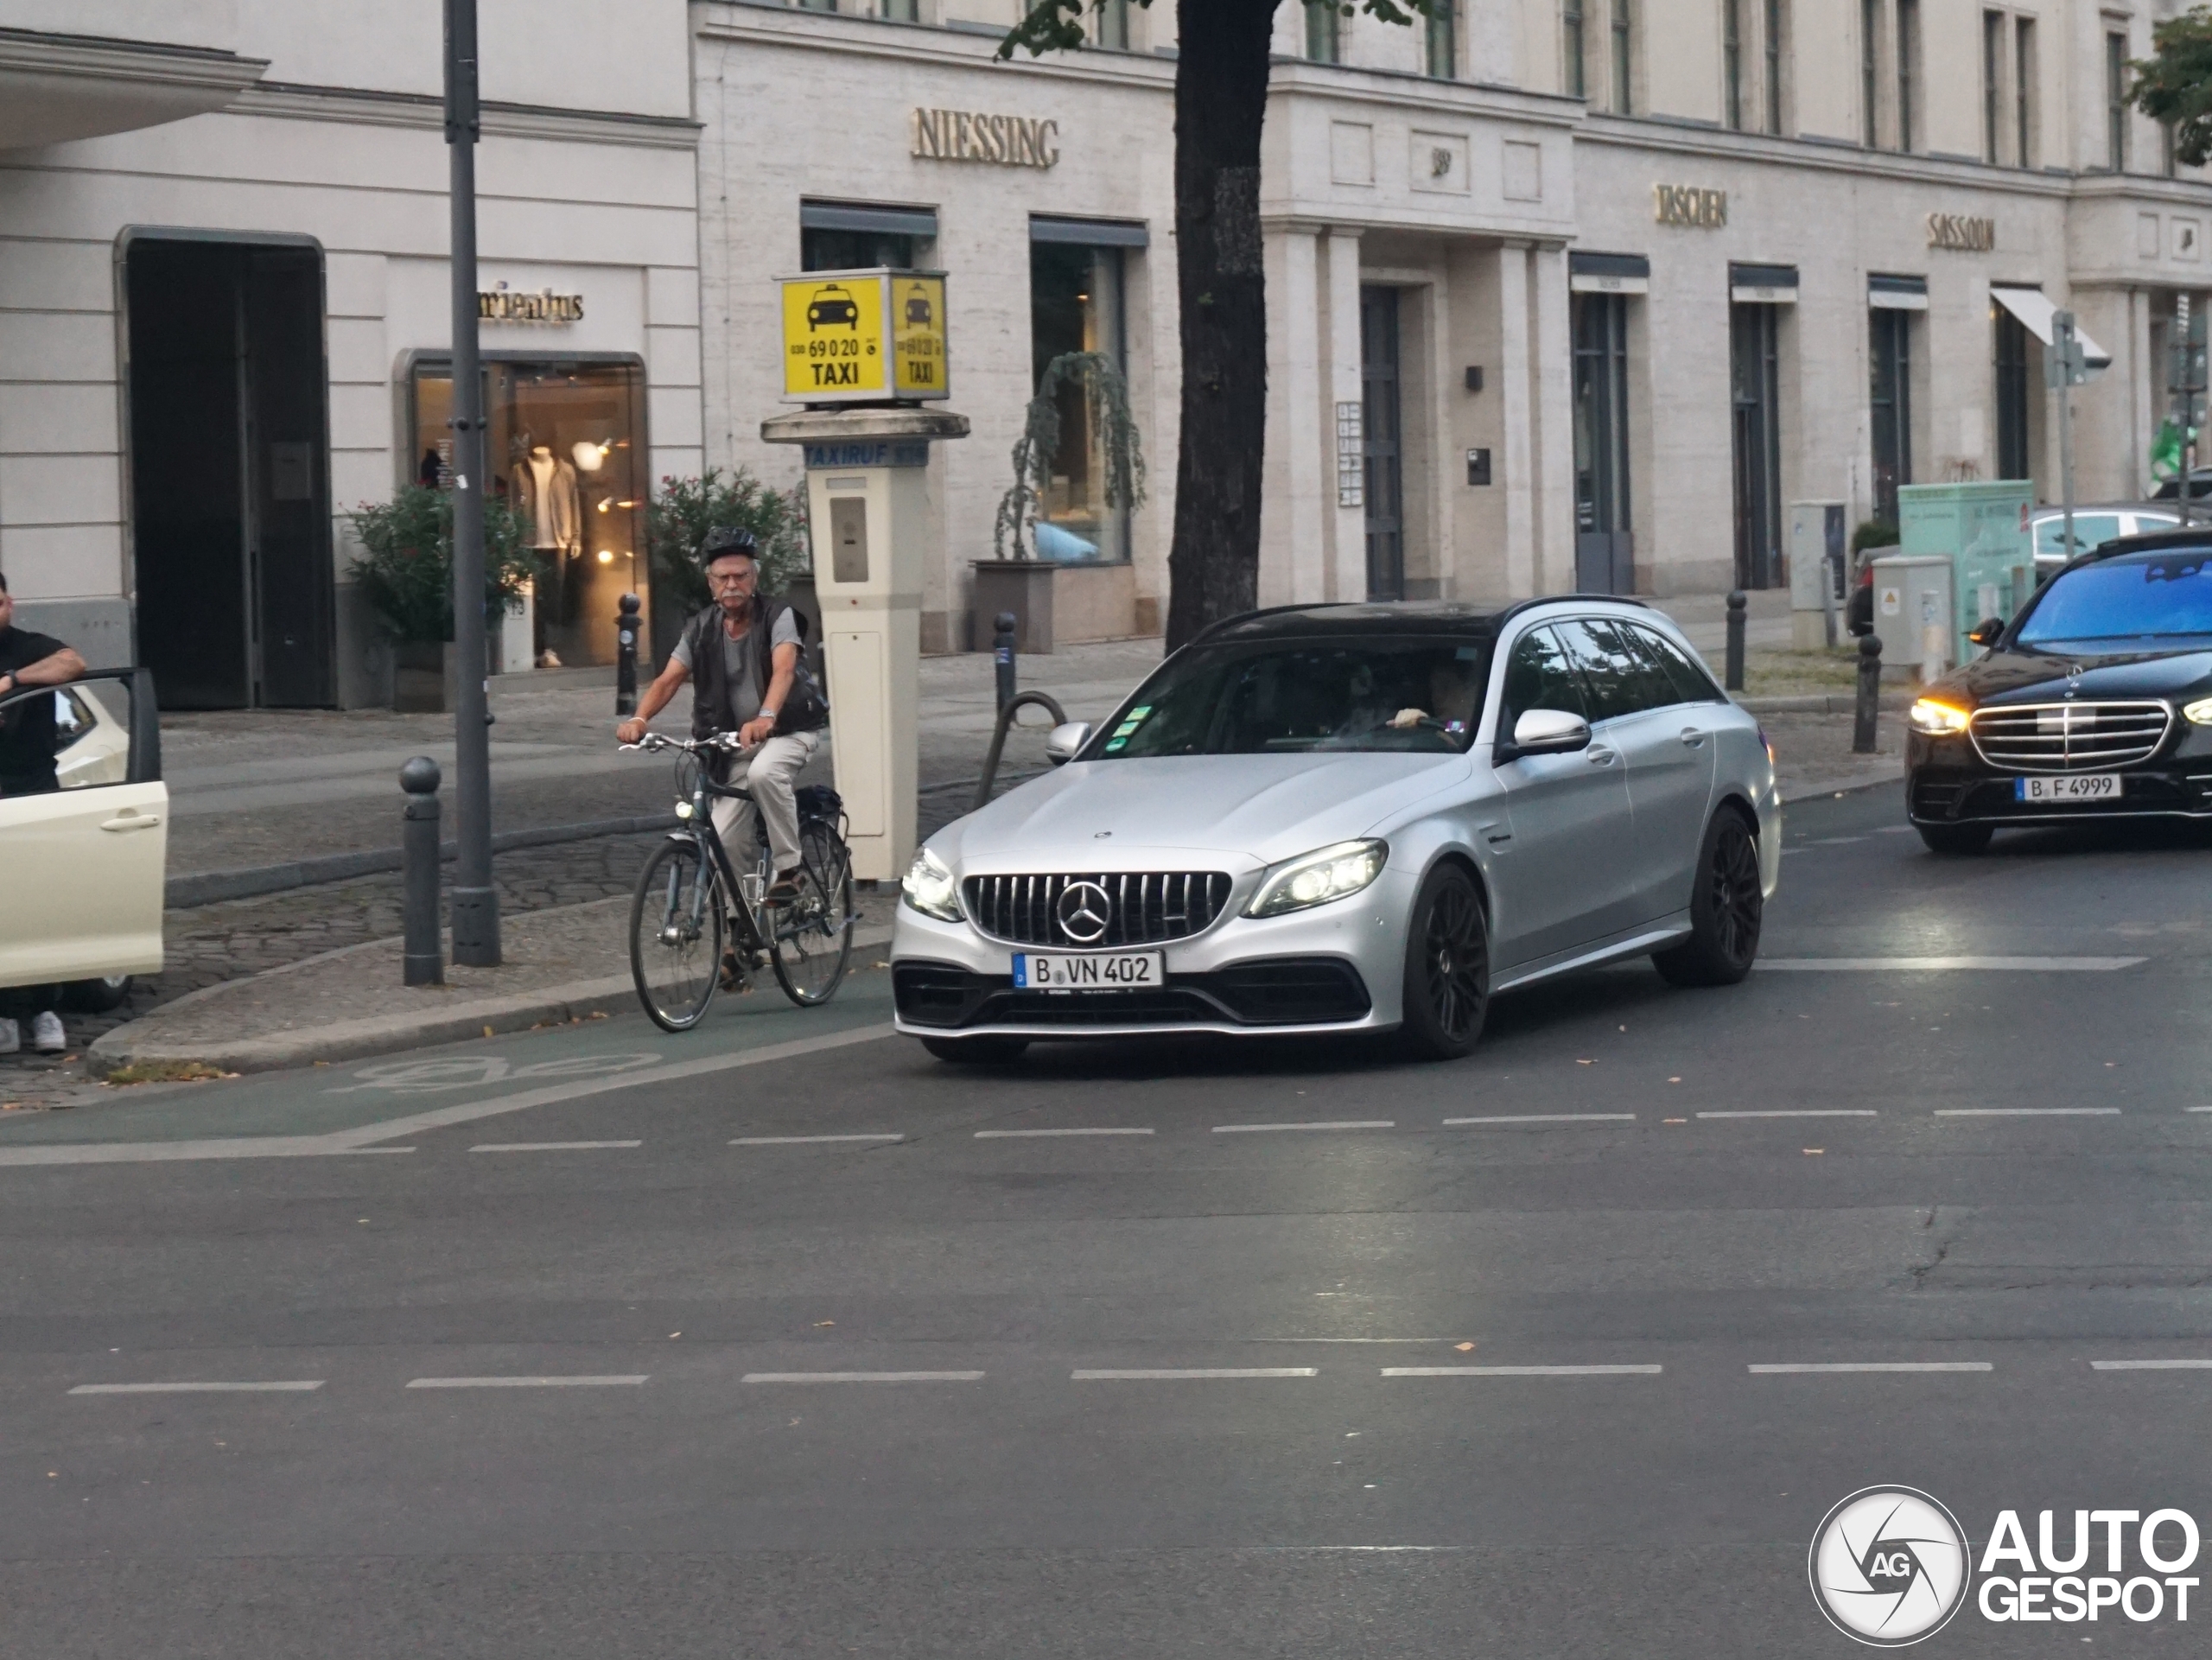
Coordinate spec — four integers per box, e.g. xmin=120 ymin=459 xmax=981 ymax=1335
xmin=124 ymin=237 xmax=336 ymax=709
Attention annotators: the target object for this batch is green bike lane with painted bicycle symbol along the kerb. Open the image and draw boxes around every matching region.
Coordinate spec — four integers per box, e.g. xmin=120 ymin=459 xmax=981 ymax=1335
xmin=0 ymin=967 xmax=892 ymax=1168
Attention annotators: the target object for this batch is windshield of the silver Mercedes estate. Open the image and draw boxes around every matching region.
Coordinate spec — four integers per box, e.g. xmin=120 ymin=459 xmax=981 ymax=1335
xmin=1093 ymin=639 xmax=1491 ymax=760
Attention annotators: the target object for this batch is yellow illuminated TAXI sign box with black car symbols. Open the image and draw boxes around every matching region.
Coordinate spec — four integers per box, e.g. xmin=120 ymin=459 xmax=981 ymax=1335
xmin=779 ymin=265 xmax=949 ymax=403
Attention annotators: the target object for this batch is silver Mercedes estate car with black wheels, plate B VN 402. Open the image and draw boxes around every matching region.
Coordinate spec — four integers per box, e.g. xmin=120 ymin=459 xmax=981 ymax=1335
xmin=892 ymin=598 xmax=1783 ymax=1060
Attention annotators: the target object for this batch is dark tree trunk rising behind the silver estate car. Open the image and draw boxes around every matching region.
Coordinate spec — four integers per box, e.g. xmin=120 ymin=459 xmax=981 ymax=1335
xmin=1168 ymin=0 xmax=1276 ymax=651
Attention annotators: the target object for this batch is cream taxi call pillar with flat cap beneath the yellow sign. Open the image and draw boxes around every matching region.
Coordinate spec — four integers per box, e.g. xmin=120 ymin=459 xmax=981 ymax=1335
xmin=761 ymin=407 xmax=969 ymax=881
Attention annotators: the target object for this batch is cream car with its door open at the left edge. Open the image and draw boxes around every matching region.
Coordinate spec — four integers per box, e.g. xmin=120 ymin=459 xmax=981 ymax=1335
xmin=0 ymin=669 xmax=168 ymax=1009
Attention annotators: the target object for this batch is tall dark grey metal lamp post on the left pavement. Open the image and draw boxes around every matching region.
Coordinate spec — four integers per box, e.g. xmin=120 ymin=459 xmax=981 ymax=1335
xmin=445 ymin=0 xmax=500 ymax=967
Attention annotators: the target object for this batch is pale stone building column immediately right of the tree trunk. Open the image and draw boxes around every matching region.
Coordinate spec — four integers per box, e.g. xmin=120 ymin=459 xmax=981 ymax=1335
xmin=1259 ymin=228 xmax=1336 ymax=604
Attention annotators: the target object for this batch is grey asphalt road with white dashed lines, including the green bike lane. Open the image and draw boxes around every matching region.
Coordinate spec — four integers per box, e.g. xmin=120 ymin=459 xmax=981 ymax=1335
xmin=0 ymin=788 xmax=2212 ymax=1660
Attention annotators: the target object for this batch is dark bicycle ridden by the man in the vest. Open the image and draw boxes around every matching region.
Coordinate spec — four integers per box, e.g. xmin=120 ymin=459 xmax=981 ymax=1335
xmin=621 ymin=733 xmax=858 ymax=1032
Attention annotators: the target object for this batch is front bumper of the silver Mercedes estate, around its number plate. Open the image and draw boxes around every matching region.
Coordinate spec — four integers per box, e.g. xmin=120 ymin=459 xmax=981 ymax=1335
xmin=892 ymin=870 xmax=1414 ymax=1038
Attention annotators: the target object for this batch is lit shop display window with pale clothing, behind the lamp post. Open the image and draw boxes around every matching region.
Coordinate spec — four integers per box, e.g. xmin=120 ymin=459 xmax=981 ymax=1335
xmin=410 ymin=359 xmax=652 ymax=669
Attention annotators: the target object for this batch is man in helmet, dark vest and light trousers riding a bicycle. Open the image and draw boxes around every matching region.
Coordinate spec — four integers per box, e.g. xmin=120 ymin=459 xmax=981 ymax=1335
xmin=615 ymin=525 xmax=830 ymax=906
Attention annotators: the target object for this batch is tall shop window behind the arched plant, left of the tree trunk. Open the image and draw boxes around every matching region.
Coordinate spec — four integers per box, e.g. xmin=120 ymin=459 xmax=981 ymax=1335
xmin=1028 ymin=243 xmax=1132 ymax=563
